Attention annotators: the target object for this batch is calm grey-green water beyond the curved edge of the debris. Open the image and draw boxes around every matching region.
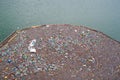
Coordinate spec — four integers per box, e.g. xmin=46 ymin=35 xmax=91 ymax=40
xmin=0 ymin=0 xmax=120 ymax=41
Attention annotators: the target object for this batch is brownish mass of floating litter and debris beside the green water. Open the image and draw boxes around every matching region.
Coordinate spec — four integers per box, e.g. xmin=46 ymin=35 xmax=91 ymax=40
xmin=0 ymin=24 xmax=120 ymax=80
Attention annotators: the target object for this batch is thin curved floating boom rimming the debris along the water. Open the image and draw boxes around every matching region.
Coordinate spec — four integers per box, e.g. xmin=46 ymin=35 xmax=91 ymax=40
xmin=0 ymin=24 xmax=120 ymax=48
